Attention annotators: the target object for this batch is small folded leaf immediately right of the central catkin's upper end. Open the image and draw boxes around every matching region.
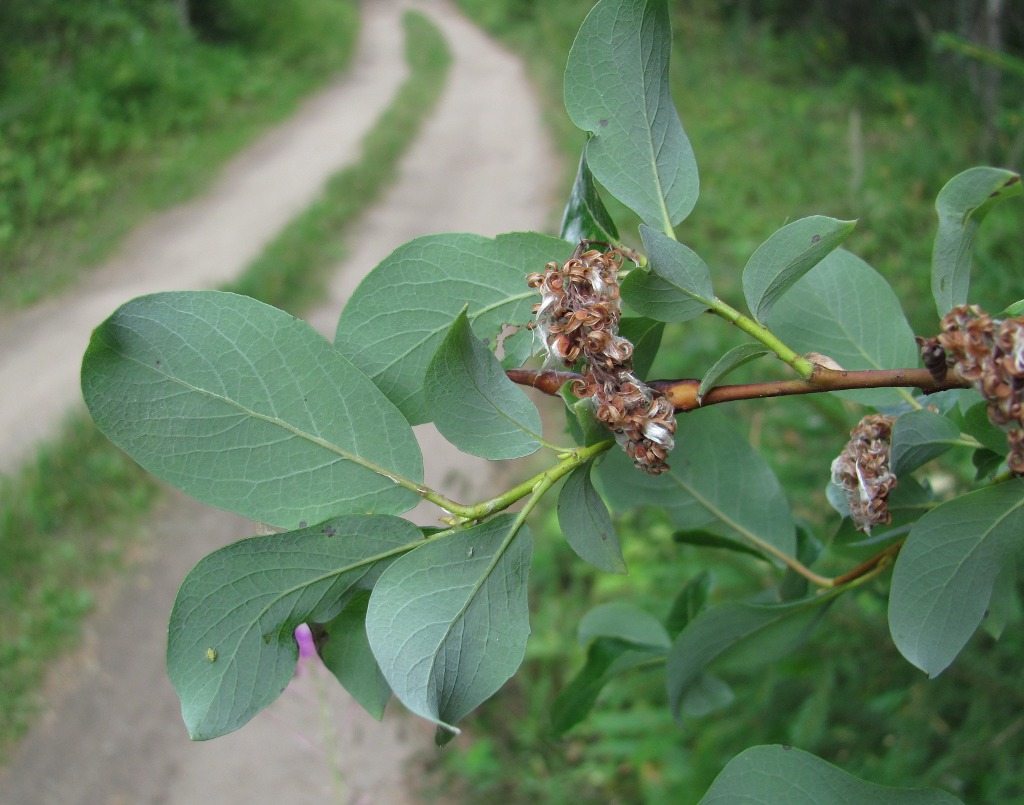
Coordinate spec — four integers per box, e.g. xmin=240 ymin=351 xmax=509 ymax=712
xmin=622 ymin=224 xmax=714 ymax=322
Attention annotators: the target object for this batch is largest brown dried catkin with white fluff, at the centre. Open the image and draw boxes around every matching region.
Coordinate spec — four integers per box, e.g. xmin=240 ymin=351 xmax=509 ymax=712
xmin=526 ymin=245 xmax=676 ymax=475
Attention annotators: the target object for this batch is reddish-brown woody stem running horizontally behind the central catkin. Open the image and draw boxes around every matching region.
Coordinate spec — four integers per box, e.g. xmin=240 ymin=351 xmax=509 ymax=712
xmin=506 ymin=366 xmax=971 ymax=412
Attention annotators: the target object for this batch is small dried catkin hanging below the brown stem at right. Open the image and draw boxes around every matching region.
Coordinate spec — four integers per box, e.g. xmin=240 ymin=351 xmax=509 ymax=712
xmin=831 ymin=414 xmax=896 ymax=534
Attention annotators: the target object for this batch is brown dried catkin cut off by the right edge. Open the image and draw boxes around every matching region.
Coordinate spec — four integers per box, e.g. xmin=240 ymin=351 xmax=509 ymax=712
xmin=938 ymin=305 xmax=1024 ymax=475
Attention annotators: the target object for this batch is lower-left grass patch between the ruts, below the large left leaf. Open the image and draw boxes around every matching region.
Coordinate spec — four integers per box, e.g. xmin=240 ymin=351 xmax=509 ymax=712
xmin=0 ymin=417 xmax=159 ymax=757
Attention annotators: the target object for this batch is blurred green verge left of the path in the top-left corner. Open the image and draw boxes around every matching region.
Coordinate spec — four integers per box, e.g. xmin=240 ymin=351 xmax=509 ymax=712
xmin=0 ymin=0 xmax=358 ymax=308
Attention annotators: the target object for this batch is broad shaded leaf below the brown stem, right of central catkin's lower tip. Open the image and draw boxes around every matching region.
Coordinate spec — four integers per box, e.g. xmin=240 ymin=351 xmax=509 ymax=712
xmin=597 ymin=409 xmax=796 ymax=556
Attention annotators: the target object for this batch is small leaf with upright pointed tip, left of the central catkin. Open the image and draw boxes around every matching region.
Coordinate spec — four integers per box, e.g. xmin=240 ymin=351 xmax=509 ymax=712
xmin=423 ymin=308 xmax=543 ymax=461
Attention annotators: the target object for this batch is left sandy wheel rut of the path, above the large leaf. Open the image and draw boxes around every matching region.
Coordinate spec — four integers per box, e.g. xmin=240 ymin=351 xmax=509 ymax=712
xmin=0 ymin=0 xmax=407 ymax=472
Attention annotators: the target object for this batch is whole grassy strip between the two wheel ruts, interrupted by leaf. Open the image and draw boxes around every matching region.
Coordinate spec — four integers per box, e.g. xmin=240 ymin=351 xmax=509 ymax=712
xmin=0 ymin=7 xmax=451 ymax=758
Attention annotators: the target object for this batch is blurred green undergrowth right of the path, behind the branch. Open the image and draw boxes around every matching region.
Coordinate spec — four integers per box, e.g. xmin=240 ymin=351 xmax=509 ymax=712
xmin=442 ymin=0 xmax=1024 ymax=803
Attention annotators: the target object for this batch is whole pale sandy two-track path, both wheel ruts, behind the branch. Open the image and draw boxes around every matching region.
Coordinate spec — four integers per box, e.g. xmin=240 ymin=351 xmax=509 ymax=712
xmin=0 ymin=0 xmax=558 ymax=805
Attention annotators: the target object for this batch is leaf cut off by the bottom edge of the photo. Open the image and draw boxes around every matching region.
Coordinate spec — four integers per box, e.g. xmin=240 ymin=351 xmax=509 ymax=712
xmin=699 ymin=746 xmax=963 ymax=805
